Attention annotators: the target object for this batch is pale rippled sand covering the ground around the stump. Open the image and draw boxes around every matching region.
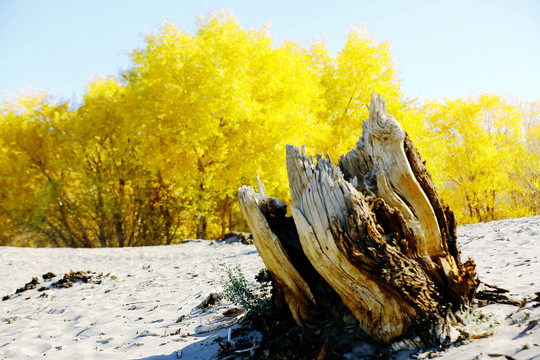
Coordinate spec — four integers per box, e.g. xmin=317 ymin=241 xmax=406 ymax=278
xmin=0 ymin=216 xmax=540 ymax=360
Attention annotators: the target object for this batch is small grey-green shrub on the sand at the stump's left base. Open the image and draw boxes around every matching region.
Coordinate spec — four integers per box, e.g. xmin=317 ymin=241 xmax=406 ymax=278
xmin=221 ymin=265 xmax=270 ymax=314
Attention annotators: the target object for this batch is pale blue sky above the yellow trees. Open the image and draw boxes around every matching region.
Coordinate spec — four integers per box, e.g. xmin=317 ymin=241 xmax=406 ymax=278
xmin=0 ymin=0 xmax=540 ymax=101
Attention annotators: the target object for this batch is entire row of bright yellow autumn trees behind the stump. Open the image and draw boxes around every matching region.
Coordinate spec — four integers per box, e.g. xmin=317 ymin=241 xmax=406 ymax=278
xmin=0 ymin=13 xmax=540 ymax=247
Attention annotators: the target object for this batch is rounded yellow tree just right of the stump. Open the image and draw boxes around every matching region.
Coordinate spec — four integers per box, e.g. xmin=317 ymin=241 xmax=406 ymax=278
xmin=422 ymin=94 xmax=532 ymax=223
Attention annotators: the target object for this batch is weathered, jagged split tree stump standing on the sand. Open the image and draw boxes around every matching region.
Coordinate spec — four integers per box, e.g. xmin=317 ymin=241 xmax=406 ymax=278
xmin=239 ymin=95 xmax=478 ymax=344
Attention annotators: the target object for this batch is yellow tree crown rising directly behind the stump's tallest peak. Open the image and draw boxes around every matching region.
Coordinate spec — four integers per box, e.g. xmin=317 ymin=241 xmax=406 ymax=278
xmin=310 ymin=28 xmax=405 ymax=160
